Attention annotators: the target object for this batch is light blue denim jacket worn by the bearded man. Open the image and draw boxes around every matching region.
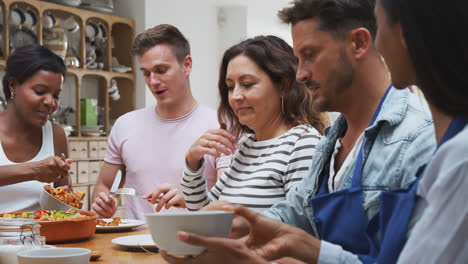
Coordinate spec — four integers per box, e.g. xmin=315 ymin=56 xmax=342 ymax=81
xmin=263 ymin=88 xmax=436 ymax=260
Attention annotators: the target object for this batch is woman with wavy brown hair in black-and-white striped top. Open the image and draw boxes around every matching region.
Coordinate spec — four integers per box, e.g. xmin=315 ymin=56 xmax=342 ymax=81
xmin=148 ymin=36 xmax=325 ymax=210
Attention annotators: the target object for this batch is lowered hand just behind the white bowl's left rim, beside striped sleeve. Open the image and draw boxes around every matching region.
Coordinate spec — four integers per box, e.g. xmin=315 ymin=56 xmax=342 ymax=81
xmin=141 ymin=183 xmax=187 ymax=212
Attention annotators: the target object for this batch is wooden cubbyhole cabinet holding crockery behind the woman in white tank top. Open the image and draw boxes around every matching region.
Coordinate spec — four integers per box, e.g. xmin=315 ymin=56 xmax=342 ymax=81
xmin=0 ymin=0 xmax=136 ymax=136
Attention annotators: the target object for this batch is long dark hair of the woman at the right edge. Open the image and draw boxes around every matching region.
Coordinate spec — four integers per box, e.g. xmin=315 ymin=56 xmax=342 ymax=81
xmin=380 ymin=0 xmax=468 ymax=117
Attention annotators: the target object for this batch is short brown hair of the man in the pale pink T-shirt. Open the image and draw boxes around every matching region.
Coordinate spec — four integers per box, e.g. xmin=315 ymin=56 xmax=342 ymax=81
xmin=131 ymin=24 xmax=190 ymax=63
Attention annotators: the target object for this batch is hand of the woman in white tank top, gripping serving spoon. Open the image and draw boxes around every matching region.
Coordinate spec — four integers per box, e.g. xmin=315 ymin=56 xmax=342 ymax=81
xmin=28 ymin=156 xmax=73 ymax=183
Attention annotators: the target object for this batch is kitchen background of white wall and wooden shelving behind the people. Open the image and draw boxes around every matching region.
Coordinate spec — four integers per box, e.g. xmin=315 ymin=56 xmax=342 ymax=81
xmin=0 ymin=0 xmax=291 ymax=216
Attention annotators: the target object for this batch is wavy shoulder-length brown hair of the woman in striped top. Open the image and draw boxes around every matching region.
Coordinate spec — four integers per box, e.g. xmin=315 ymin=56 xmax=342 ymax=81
xmin=218 ymin=36 xmax=327 ymax=137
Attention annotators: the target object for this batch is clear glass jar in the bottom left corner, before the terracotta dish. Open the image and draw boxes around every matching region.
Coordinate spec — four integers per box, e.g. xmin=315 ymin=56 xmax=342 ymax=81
xmin=0 ymin=219 xmax=45 ymax=264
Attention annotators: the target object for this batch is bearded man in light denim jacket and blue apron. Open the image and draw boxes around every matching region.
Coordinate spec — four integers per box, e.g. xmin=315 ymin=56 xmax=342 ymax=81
xmin=163 ymin=0 xmax=436 ymax=263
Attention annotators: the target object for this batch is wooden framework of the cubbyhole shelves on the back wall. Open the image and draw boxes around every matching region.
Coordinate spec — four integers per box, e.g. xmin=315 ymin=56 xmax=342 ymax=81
xmin=0 ymin=0 xmax=136 ymax=137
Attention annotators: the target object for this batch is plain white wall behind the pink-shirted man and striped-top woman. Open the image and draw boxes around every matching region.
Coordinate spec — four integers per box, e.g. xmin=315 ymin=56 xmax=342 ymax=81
xmin=114 ymin=0 xmax=292 ymax=109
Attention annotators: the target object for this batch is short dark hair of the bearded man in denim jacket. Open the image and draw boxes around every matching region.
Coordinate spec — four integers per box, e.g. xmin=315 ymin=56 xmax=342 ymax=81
xmin=278 ymin=0 xmax=377 ymax=39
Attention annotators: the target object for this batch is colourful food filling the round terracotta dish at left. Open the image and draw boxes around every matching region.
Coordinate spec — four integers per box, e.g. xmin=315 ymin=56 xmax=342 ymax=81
xmin=0 ymin=208 xmax=87 ymax=221
